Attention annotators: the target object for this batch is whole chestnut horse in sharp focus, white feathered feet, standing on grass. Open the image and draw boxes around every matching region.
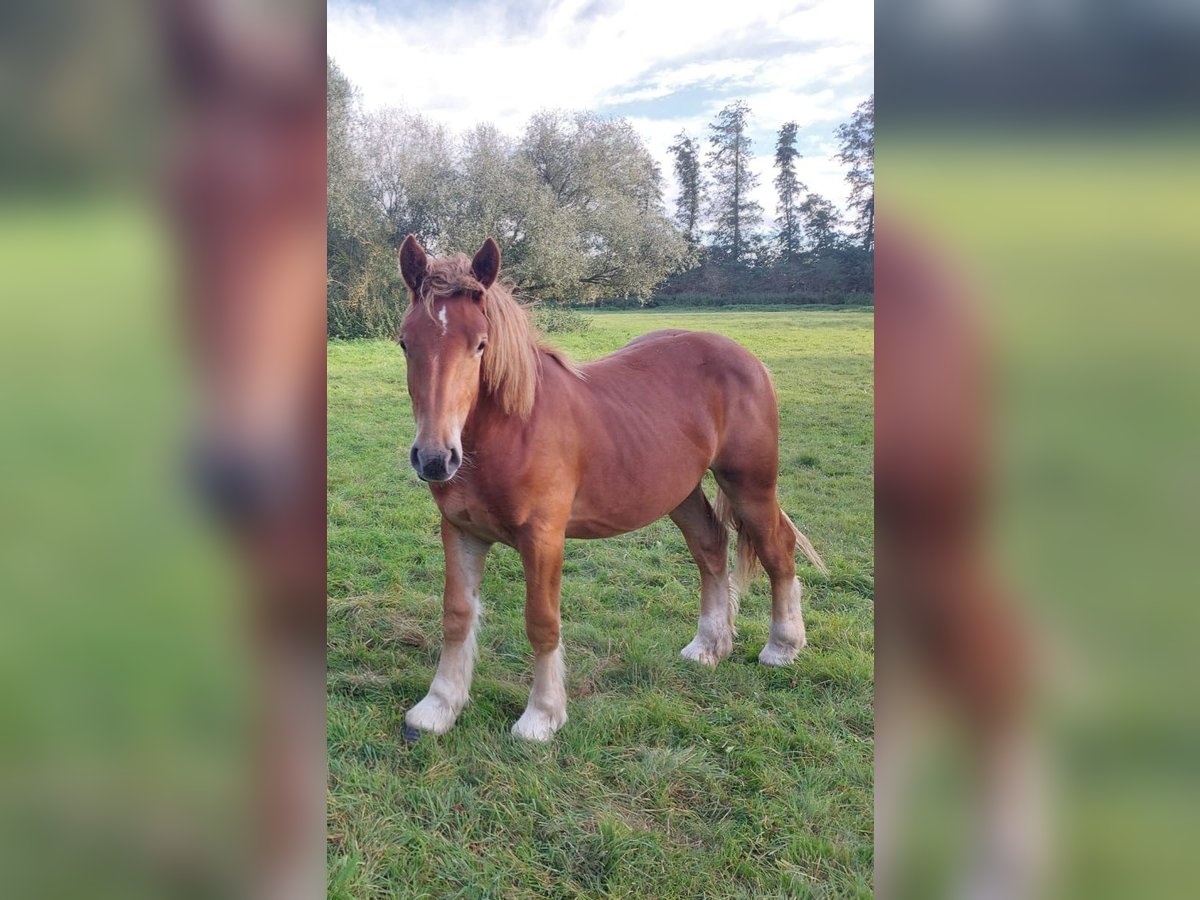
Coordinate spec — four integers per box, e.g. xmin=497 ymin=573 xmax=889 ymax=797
xmin=398 ymin=234 xmax=828 ymax=742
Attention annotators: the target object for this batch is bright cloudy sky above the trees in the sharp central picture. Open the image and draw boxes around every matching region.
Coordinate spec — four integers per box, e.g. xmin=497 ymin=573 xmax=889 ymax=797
xmin=328 ymin=0 xmax=875 ymax=224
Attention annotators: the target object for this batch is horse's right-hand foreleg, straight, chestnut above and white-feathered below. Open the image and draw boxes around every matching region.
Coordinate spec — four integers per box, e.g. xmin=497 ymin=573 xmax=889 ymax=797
xmin=512 ymin=530 xmax=566 ymax=740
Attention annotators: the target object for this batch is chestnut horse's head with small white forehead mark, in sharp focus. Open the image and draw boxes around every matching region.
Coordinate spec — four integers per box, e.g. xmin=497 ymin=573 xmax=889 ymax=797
xmin=400 ymin=235 xmax=500 ymax=481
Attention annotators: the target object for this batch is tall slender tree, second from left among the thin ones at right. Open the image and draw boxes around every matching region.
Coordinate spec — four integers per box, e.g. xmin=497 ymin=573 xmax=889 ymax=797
xmin=708 ymin=100 xmax=762 ymax=262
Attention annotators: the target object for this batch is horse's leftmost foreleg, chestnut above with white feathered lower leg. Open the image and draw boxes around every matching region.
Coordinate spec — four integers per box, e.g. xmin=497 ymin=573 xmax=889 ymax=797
xmin=404 ymin=518 xmax=491 ymax=737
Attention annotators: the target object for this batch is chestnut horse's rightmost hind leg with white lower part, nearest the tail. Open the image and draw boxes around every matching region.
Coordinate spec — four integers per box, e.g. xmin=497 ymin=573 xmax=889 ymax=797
xmin=718 ymin=482 xmax=808 ymax=666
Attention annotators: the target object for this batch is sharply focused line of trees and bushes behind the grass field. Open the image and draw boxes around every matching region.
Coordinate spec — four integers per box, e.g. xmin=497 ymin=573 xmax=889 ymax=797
xmin=326 ymin=60 xmax=874 ymax=337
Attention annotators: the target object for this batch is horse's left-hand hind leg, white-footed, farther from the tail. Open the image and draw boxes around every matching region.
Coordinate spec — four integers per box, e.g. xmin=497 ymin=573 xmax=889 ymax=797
xmin=671 ymin=485 xmax=736 ymax=666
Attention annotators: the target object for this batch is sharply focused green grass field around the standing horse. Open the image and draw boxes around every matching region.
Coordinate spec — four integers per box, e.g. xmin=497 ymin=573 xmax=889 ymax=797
xmin=329 ymin=310 xmax=874 ymax=898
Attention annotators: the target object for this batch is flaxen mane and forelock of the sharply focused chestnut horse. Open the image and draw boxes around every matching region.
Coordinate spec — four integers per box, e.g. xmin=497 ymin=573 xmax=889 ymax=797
xmin=406 ymin=253 xmax=583 ymax=419
